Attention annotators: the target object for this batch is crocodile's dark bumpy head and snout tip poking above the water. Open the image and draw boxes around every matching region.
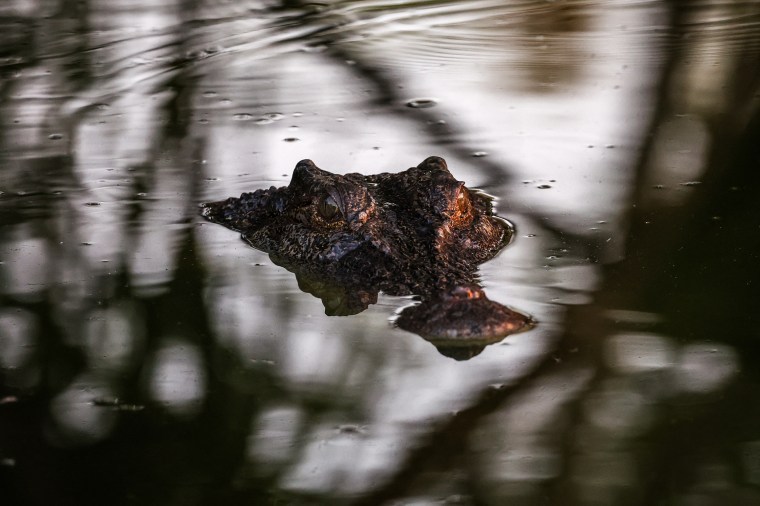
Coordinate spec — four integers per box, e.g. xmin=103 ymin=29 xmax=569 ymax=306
xmin=202 ymin=156 xmax=532 ymax=359
